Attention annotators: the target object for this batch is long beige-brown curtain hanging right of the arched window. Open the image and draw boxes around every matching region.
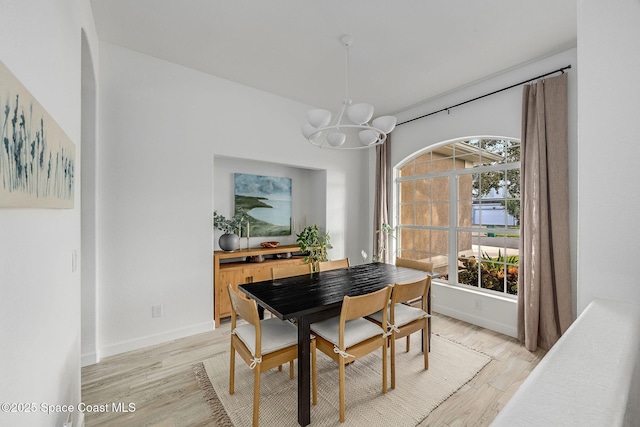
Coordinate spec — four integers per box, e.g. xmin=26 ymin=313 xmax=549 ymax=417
xmin=518 ymin=73 xmax=573 ymax=351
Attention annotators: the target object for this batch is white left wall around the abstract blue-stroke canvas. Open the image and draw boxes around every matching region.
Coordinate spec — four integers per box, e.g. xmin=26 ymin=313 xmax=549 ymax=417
xmin=0 ymin=0 xmax=96 ymax=426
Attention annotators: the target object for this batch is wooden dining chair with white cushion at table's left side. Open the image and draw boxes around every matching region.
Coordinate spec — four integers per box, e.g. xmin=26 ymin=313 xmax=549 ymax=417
xmin=227 ymin=285 xmax=318 ymax=427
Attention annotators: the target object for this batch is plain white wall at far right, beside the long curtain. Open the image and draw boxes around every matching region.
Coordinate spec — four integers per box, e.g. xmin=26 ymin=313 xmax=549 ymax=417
xmin=578 ymin=0 xmax=640 ymax=312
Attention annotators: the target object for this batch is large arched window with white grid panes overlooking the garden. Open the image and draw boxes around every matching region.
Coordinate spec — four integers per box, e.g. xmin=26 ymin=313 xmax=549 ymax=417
xmin=395 ymin=136 xmax=520 ymax=296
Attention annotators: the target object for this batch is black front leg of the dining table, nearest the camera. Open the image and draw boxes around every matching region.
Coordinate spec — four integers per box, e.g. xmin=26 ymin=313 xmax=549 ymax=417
xmin=297 ymin=316 xmax=311 ymax=426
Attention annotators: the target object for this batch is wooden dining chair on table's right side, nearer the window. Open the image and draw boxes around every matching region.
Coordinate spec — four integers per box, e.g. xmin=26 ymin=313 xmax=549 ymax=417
xmin=367 ymin=276 xmax=431 ymax=388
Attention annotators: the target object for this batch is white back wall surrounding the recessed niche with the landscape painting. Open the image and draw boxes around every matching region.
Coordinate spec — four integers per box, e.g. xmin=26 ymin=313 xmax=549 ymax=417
xmin=97 ymin=43 xmax=369 ymax=357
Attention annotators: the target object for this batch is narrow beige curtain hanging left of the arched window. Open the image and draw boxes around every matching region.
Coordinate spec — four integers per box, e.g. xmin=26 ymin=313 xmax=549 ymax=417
xmin=373 ymin=135 xmax=391 ymax=263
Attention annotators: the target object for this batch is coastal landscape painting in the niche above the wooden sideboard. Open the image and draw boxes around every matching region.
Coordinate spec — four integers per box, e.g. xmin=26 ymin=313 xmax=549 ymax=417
xmin=234 ymin=173 xmax=291 ymax=237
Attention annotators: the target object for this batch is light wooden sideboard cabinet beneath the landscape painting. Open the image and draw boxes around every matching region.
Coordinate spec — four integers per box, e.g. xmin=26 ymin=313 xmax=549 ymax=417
xmin=213 ymin=245 xmax=304 ymax=328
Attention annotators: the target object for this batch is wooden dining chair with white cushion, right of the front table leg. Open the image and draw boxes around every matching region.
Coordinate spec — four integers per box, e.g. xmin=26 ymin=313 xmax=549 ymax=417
xmin=311 ymin=285 xmax=391 ymax=422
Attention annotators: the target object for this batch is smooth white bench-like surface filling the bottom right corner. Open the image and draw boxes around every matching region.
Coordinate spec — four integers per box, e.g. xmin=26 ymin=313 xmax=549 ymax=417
xmin=491 ymin=299 xmax=640 ymax=427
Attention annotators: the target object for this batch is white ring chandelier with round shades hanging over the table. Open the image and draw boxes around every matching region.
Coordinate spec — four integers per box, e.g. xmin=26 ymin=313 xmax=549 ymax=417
xmin=302 ymin=35 xmax=396 ymax=150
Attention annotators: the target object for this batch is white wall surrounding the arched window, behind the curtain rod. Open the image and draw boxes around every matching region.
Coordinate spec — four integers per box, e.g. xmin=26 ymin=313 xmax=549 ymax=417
xmin=391 ymin=49 xmax=577 ymax=336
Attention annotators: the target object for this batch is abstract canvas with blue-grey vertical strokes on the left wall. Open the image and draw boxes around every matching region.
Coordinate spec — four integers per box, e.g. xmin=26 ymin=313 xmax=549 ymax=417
xmin=0 ymin=62 xmax=76 ymax=209
